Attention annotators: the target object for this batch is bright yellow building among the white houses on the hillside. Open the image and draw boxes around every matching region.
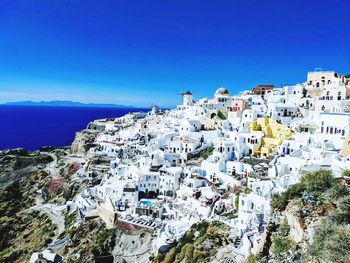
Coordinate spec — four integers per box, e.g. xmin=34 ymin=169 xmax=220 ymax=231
xmin=249 ymin=118 xmax=292 ymax=157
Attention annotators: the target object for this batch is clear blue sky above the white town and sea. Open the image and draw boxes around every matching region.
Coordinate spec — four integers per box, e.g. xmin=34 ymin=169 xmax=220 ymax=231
xmin=0 ymin=0 xmax=350 ymax=106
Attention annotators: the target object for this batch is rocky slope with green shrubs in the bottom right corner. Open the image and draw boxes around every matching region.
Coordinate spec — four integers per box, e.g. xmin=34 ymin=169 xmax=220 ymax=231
xmin=252 ymin=170 xmax=350 ymax=263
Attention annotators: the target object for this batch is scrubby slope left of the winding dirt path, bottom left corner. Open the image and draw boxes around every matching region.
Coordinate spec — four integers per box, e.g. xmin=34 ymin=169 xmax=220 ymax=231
xmin=0 ymin=170 xmax=56 ymax=262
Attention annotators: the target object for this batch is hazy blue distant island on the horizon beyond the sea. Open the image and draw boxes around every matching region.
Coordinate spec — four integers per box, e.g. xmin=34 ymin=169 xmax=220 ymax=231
xmin=0 ymin=100 xmax=135 ymax=108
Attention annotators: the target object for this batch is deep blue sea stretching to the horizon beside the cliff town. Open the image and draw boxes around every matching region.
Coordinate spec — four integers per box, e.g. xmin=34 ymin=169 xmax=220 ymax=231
xmin=0 ymin=105 xmax=149 ymax=150
